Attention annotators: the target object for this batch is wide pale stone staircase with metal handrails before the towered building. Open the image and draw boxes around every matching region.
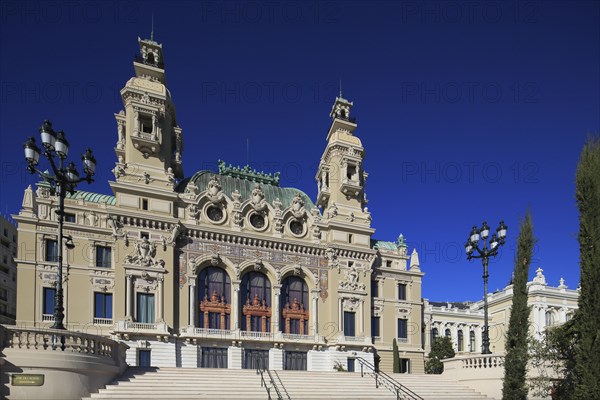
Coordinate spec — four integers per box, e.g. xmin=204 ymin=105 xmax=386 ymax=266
xmin=84 ymin=368 xmax=486 ymax=400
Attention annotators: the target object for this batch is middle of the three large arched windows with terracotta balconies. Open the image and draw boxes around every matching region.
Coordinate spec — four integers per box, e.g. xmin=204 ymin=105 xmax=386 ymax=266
xmin=240 ymin=271 xmax=271 ymax=332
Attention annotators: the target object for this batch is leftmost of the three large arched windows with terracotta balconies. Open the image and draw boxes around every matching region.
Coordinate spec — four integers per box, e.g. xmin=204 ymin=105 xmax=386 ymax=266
xmin=198 ymin=267 xmax=231 ymax=329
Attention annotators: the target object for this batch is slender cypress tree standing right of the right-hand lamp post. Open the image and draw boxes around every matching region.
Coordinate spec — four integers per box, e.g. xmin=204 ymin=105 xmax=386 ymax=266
xmin=502 ymin=210 xmax=536 ymax=400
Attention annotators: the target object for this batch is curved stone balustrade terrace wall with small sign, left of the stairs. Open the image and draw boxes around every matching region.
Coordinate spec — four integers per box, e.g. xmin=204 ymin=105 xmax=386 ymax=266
xmin=0 ymin=325 xmax=128 ymax=400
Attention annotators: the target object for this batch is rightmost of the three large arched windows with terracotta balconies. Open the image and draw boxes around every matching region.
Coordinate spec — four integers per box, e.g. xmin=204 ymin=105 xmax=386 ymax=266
xmin=281 ymin=276 xmax=309 ymax=335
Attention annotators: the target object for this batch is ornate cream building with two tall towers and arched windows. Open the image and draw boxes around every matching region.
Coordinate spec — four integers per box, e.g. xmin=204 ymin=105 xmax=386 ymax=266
xmin=15 ymin=39 xmax=424 ymax=373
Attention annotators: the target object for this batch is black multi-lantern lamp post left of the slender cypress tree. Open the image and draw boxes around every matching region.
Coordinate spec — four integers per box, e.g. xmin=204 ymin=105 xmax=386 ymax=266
xmin=465 ymin=221 xmax=507 ymax=354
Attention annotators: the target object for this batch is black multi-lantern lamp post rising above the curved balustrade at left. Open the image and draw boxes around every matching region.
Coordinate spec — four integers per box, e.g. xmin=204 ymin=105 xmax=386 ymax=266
xmin=23 ymin=120 xmax=96 ymax=329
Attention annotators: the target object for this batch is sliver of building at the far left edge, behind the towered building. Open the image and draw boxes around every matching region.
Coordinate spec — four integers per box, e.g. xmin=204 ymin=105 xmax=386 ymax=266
xmin=0 ymin=215 xmax=17 ymax=324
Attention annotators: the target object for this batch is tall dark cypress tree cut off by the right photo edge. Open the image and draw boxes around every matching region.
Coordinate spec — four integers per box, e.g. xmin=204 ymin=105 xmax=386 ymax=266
xmin=573 ymin=138 xmax=600 ymax=400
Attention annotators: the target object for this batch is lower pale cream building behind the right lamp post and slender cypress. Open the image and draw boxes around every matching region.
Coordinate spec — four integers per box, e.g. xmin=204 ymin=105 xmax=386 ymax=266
xmin=424 ymin=268 xmax=579 ymax=355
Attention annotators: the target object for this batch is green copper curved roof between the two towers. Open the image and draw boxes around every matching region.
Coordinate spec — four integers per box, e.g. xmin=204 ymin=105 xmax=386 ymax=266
xmin=177 ymin=171 xmax=314 ymax=211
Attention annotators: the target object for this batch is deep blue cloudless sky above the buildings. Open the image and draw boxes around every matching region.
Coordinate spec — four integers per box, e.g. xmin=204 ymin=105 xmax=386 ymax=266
xmin=0 ymin=1 xmax=600 ymax=301
